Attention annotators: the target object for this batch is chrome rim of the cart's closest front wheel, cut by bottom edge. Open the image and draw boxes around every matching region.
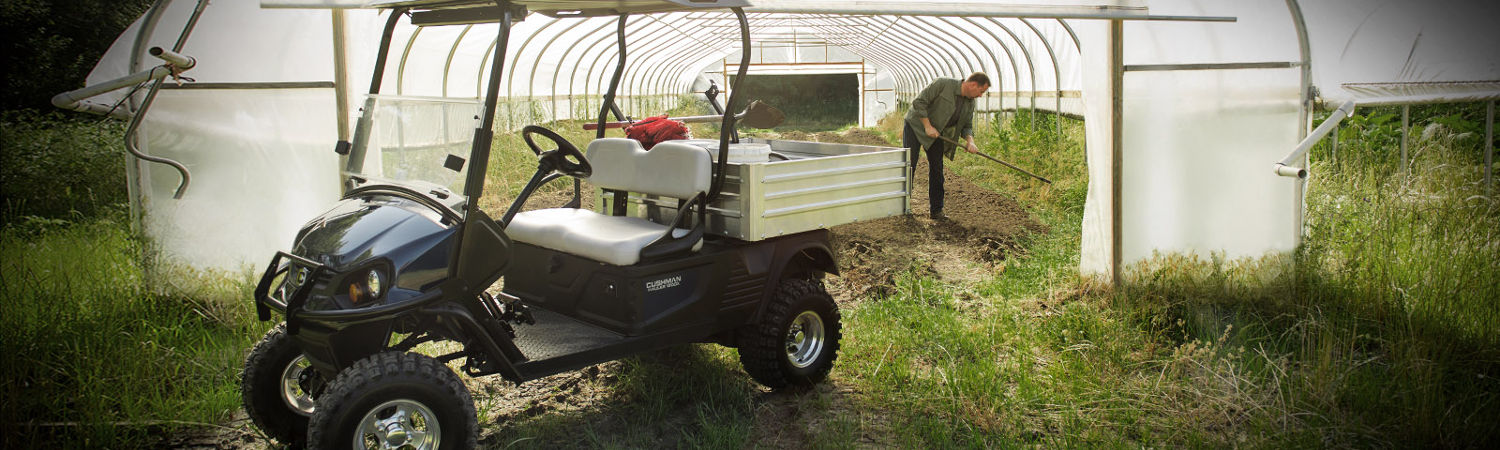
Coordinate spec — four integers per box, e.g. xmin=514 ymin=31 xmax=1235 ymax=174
xmin=354 ymin=399 xmax=443 ymax=450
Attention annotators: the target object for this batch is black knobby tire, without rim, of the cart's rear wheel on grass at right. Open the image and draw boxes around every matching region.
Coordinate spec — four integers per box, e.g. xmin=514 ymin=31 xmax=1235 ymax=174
xmin=738 ymin=279 xmax=840 ymax=389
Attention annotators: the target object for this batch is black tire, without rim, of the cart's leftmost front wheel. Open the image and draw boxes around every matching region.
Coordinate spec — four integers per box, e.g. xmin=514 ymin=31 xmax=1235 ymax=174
xmin=240 ymin=323 xmax=308 ymax=449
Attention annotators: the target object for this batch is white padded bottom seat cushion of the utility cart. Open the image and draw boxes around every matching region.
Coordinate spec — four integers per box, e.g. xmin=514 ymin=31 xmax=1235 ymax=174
xmin=506 ymin=209 xmax=702 ymax=266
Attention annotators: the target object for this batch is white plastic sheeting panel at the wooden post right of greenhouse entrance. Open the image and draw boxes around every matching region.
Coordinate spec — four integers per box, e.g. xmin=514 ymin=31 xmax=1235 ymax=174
xmin=1083 ymin=2 xmax=1302 ymax=273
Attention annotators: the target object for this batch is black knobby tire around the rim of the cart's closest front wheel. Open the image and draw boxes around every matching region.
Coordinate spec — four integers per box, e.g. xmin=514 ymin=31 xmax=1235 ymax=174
xmin=308 ymin=351 xmax=479 ymax=450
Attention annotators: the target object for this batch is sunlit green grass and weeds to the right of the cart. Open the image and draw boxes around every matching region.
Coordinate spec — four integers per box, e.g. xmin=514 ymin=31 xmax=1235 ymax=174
xmin=836 ymin=106 xmax=1500 ymax=447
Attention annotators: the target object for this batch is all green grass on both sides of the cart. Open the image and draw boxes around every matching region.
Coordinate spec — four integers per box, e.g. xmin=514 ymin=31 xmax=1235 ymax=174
xmin=0 ymin=98 xmax=1500 ymax=449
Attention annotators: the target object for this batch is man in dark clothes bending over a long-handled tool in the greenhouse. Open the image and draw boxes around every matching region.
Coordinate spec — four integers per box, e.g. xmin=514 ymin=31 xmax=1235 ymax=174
xmin=902 ymin=72 xmax=990 ymax=221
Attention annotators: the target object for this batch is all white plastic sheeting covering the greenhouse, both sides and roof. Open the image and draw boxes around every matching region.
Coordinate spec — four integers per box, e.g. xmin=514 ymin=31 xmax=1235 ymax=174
xmin=79 ymin=0 xmax=1500 ymax=273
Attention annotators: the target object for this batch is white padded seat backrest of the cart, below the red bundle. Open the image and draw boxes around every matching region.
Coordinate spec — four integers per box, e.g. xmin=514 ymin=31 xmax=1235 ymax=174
xmin=588 ymin=138 xmax=713 ymax=200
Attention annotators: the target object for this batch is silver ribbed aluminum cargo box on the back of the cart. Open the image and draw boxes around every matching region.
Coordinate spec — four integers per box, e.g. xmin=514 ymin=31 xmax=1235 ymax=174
xmin=596 ymin=138 xmax=912 ymax=242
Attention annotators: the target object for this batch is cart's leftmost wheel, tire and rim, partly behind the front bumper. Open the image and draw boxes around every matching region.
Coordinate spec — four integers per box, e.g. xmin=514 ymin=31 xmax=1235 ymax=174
xmin=240 ymin=324 xmax=317 ymax=447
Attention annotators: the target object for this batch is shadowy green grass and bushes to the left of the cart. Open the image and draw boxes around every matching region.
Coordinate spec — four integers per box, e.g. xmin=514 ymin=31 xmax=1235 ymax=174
xmin=0 ymin=111 xmax=266 ymax=447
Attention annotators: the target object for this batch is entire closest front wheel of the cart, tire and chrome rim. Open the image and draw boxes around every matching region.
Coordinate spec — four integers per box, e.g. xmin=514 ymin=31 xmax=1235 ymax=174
xmin=308 ymin=351 xmax=479 ymax=450
